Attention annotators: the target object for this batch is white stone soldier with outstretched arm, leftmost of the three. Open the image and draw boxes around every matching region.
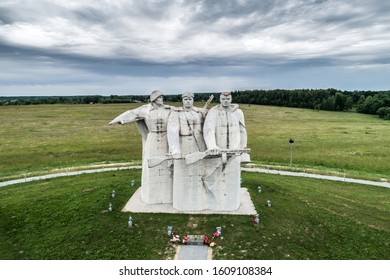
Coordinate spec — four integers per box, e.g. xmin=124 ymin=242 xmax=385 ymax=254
xmin=109 ymin=90 xmax=172 ymax=204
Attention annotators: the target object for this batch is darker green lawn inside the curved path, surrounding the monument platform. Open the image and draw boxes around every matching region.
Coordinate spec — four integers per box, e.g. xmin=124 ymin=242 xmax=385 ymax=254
xmin=0 ymin=170 xmax=390 ymax=260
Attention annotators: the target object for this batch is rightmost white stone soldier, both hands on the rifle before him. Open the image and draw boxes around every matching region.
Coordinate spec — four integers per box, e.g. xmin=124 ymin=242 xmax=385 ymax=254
xmin=203 ymin=92 xmax=250 ymax=211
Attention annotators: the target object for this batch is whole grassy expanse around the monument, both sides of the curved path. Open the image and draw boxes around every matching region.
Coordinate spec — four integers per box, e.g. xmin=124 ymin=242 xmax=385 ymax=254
xmin=0 ymin=104 xmax=390 ymax=259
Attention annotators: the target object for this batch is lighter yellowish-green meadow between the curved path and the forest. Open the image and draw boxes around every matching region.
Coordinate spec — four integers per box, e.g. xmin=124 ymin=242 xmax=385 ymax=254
xmin=0 ymin=104 xmax=390 ymax=181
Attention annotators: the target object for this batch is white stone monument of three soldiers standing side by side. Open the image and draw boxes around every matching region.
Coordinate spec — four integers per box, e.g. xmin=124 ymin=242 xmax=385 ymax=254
xmin=110 ymin=91 xmax=255 ymax=214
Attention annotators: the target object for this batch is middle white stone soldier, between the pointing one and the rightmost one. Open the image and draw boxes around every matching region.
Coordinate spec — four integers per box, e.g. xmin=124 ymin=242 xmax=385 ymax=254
xmin=168 ymin=93 xmax=208 ymax=211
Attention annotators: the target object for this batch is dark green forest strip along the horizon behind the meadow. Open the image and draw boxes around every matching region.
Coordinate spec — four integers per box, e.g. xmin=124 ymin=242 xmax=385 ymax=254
xmin=0 ymin=88 xmax=390 ymax=120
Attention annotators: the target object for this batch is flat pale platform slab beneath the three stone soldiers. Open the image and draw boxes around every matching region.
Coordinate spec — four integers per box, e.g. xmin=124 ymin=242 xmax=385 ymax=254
xmin=122 ymin=188 xmax=257 ymax=215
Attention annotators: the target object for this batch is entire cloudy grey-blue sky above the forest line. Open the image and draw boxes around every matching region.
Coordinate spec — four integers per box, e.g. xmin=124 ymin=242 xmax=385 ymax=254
xmin=0 ymin=0 xmax=390 ymax=96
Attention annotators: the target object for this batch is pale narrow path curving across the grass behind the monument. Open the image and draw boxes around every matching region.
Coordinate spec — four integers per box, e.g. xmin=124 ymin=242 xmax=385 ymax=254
xmin=0 ymin=166 xmax=390 ymax=188
